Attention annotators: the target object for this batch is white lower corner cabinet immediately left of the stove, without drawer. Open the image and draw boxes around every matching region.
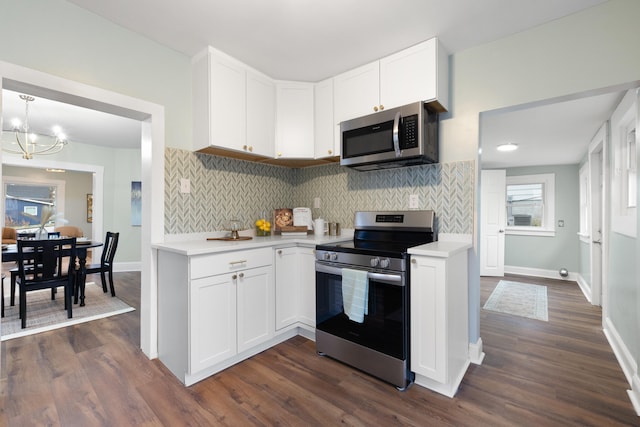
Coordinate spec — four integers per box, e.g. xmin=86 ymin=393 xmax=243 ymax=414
xmin=275 ymin=246 xmax=316 ymax=330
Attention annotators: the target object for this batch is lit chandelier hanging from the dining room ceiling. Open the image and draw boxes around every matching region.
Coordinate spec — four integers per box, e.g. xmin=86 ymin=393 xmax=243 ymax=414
xmin=2 ymin=95 xmax=67 ymax=160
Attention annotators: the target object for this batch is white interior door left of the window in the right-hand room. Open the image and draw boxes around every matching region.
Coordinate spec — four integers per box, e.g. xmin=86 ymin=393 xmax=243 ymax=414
xmin=480 ymin=169 xmax=507 ymax=277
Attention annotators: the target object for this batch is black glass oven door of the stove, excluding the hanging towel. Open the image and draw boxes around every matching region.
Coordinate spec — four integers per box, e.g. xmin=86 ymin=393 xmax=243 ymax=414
xmin=316 ymin=261 xmax=409 ymax=360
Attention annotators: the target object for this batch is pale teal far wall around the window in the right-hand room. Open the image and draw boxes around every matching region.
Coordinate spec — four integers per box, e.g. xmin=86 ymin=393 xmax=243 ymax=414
xmin=504 ymin=165 xmax=580 ymax=272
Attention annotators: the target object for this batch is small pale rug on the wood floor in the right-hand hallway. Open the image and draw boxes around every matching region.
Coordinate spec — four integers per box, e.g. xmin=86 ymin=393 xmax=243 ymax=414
xmin=483 ymin=280 xmax=549 ymax=322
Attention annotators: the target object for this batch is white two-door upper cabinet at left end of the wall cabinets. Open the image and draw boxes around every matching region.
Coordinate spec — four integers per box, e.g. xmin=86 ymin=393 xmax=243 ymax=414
xmin=193 ymin=47 xmax=275 ymax=157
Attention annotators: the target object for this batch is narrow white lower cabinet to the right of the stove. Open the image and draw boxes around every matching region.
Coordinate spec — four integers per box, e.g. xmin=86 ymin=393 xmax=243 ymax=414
xmin=410 ymin=250 xmax=469 ymax=397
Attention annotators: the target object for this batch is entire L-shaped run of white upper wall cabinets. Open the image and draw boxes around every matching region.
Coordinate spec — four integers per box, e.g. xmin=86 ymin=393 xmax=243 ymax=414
xmin=192 ymin=38 xmax=449 ymax=163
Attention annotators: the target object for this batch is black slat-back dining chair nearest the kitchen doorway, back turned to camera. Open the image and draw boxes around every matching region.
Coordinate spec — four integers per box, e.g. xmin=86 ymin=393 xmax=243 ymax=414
xmin=16 ymin=237 xmax=76 ymax=329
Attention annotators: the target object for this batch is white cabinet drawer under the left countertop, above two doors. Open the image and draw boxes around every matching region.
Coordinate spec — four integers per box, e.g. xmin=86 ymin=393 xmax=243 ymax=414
xmin=190 ymin=248 xmax=273 ymax=280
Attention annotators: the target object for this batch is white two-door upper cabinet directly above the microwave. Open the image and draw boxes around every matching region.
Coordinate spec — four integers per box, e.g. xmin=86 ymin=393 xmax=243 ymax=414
xmin=334 ymin=38 xmax=449 ymax=124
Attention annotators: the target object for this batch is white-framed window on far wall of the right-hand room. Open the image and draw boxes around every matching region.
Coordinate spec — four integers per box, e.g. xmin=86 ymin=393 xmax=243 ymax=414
xmin=506 ymin=174 xmax=555 ymax=236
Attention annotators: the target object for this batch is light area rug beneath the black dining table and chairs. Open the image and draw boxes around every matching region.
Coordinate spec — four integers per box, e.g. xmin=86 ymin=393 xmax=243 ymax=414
xmin=0 ymin=282 xmax=135 ymax=341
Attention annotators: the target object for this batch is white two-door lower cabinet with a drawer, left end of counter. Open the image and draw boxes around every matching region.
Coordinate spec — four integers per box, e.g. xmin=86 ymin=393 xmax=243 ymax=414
xmin=158 ymin=248 xmax=275 ymax=385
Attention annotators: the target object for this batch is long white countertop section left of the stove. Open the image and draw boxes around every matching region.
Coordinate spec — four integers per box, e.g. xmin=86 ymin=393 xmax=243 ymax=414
xmin=151 ymin=230 xmax=353 ymax=256
